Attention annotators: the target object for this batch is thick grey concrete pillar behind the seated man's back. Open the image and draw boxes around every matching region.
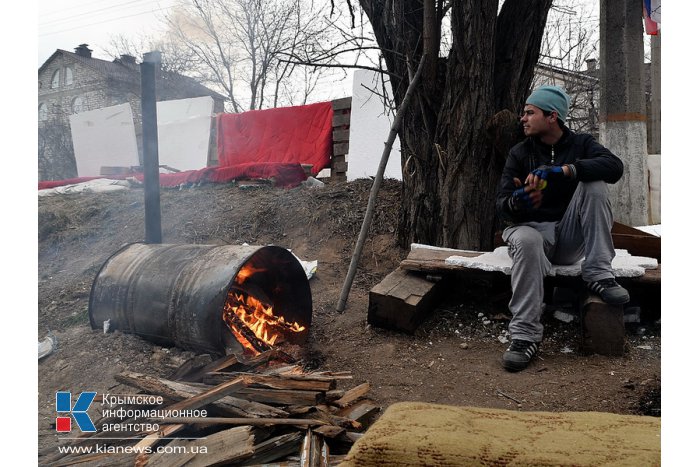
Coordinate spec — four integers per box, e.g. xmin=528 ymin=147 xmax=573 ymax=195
xmin=600 ymin=0 xmax=649 ymax=226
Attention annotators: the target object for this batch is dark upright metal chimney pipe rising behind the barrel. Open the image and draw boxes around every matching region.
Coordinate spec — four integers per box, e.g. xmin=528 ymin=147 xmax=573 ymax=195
xmin=141 ymin=52 xmax=162 ymax=243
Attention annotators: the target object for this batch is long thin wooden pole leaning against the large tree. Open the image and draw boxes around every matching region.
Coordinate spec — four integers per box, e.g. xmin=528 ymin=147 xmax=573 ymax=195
xmin=335 ymin=55 xmax=425 ymax=313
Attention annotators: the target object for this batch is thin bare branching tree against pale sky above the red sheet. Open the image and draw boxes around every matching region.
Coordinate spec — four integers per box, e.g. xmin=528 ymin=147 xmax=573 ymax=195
xmin=161 ymin=0 xmax=340 ymax=112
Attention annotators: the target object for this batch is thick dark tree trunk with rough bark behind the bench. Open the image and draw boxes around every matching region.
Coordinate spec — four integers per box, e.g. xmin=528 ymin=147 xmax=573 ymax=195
xmin=360 ymin=0 xmax=552 ymax=249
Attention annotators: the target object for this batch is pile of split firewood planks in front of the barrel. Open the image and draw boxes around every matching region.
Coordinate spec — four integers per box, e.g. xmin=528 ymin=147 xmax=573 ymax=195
xmin=39 ymin=349 xmax=380 ymax=467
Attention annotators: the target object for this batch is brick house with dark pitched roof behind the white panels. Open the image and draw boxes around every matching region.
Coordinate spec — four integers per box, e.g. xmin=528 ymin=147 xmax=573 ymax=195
xmin=38 ymin=44 xmax=225 ymax=180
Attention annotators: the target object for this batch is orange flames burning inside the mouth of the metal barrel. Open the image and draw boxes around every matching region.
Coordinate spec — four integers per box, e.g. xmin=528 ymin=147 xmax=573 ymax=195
xmin=223 ymin=291 xmax=306 ymax=354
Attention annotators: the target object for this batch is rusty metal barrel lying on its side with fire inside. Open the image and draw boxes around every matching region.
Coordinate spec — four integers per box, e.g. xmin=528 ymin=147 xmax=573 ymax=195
xmin=88 ymin=243 xmax=312 ymax=354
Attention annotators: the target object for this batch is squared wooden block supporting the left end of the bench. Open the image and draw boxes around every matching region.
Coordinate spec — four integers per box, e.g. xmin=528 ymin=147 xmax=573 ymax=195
xmin=367 ymin=268 xmax=439 ymax=333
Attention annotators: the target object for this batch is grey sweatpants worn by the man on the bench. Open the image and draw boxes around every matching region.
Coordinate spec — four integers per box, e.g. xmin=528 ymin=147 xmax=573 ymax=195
xmin=503 ymin=181 xmax=615 ymax=342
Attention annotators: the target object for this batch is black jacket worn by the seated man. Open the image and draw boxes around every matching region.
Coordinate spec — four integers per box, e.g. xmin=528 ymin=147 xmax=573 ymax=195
xmin=496 ymin=128 xmax=623 ymax=225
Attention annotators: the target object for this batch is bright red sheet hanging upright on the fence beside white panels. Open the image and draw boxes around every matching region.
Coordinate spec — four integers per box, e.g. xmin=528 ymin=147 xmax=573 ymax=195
xmin=216 ymin=102 xmax=333 ymax=175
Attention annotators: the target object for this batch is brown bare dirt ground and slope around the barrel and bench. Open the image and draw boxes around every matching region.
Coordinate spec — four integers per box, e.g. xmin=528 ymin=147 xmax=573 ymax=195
xmin=38 ymin=179 xmax=661 ymax=458
